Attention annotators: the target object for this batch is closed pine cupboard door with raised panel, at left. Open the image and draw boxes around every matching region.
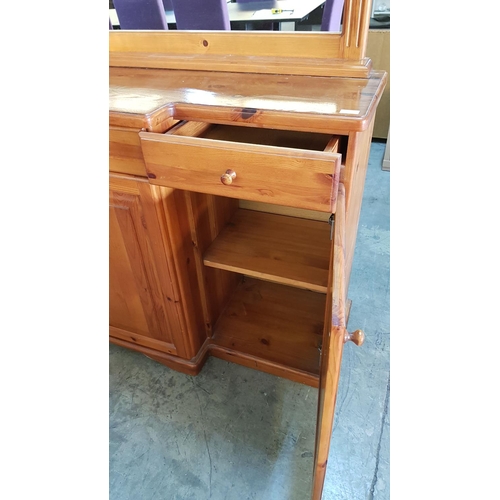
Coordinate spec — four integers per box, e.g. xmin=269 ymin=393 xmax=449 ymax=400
xmin=109 ymin=175 xmax=186 ymax=357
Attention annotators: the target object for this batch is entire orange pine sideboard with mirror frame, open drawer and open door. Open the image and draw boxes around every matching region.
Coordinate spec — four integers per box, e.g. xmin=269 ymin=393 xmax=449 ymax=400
xmin=109 ymin=0 xmax=386 ymax=500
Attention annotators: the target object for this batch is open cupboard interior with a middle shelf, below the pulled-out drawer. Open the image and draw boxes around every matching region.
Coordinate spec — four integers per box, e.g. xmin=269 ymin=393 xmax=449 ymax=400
xmin=189 ymin=189 xmax=332 ymax=387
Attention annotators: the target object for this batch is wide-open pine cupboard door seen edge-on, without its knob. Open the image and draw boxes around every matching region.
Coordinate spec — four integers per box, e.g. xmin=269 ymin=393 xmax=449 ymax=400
xmin=311 ymin=184 xmax=347 ymax=500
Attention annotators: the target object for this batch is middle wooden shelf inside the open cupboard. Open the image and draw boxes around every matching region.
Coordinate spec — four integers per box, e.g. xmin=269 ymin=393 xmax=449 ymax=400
xmin=203 ymin=209 xmax=331 ymax=293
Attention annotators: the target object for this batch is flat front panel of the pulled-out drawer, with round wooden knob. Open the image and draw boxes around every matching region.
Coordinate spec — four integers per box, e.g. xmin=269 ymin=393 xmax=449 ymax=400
xmin=139 ymin=132 xmax=341 ymax=212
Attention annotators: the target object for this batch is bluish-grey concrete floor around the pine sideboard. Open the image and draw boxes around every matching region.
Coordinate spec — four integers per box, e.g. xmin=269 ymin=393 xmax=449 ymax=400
xmin=109 ymin=141 xmax=390 ymax=500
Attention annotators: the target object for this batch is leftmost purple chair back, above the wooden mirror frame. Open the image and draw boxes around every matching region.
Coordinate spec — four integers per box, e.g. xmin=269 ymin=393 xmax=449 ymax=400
xmin=113 ymin=0 xmax=168 ymax=30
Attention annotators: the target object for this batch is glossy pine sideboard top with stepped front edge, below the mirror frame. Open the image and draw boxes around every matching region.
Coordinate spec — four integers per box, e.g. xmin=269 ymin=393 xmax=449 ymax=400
xmin=109 ymin=67 xmax=387 ymax=132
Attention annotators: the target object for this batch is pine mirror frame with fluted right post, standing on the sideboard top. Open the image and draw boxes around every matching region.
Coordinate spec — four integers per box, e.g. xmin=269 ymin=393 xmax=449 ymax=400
xmin=109 ymin=0 xmax=372 ymax=78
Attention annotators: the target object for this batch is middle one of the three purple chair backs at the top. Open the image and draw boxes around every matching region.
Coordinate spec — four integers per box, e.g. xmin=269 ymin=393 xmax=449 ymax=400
xmin=171 ymin=0 xmax=231 ymax=30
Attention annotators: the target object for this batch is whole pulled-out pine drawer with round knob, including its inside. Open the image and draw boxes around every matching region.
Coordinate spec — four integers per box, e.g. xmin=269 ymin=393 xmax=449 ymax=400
xmin=139 ymin=122 xmax=341 ymax=213
